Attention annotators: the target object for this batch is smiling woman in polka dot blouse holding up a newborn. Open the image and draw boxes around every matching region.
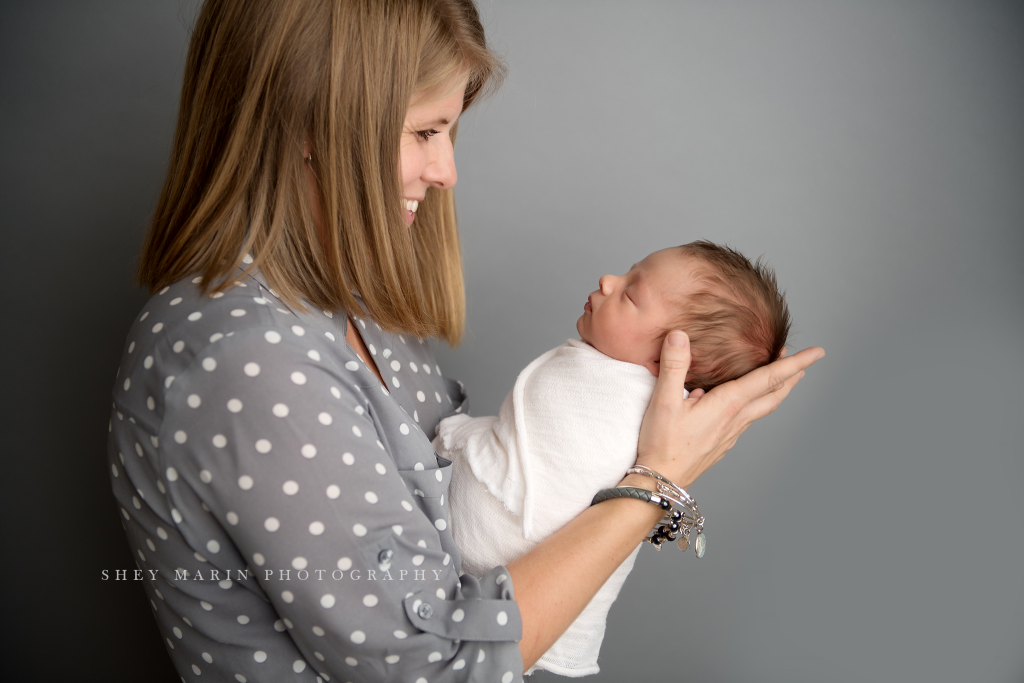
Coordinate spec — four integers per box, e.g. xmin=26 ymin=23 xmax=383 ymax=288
xmin=110 ymin=0 xmax=823 ymax=683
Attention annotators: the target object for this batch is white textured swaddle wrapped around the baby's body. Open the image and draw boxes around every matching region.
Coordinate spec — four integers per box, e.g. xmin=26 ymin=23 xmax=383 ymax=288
xmin=434 ymin=339 xmax=656 ymax=676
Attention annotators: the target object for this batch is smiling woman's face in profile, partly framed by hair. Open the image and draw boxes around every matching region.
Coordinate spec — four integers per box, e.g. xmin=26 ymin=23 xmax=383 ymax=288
xmin=399 ymin=80 xmax=466 ymax=225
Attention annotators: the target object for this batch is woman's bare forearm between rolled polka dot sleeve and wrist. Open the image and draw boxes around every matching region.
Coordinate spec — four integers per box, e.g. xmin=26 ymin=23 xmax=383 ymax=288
xmin=508 ymin=474 xmax=663 ymax=669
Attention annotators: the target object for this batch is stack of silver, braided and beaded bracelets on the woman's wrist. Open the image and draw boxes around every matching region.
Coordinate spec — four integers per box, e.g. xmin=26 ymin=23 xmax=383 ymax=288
xmin=591 ymin=465 xmax=708 ymax=557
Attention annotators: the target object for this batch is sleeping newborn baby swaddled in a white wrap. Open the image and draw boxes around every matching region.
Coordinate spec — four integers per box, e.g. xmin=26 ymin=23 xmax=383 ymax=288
xmin=434 ymin=242 xmax=790 ymax=676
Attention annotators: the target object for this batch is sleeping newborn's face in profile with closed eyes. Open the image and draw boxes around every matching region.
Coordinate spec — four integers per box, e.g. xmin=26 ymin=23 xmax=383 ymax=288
xmin=577 ymin=247 xmax=693 ymax=375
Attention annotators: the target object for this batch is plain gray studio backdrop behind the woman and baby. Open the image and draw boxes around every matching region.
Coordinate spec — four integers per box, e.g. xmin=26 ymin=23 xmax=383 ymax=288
xmin=0 ymin=0 xmax=1024 ymax=683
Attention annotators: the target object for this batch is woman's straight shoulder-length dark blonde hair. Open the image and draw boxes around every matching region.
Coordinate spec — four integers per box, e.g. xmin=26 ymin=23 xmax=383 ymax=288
xmin=137 ymin=0 xmax=504 ymax=344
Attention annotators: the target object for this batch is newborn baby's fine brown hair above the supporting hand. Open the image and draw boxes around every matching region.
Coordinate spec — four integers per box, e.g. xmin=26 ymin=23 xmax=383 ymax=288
xmin=669 ymin=240 xmax=793 ymax=391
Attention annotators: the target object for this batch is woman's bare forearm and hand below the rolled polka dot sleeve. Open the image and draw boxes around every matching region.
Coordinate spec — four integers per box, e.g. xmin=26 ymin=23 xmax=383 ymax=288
xmin=508 ymin=332 xmax=824 ymax=668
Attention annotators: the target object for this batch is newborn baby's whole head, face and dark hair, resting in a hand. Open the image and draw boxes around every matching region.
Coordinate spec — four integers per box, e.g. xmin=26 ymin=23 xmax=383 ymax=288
xmin=577 ymin=241 xmax=791 ymax=391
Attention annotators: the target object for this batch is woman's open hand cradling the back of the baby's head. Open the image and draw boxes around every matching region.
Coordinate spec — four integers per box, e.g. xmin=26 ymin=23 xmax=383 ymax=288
xmin=637 ymin=330 xmax=825 ymax=488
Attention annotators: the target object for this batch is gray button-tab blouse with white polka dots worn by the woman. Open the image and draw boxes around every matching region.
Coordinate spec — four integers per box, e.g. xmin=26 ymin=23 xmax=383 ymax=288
xmin=109 ymin=274 xmax=522 ymax=683
